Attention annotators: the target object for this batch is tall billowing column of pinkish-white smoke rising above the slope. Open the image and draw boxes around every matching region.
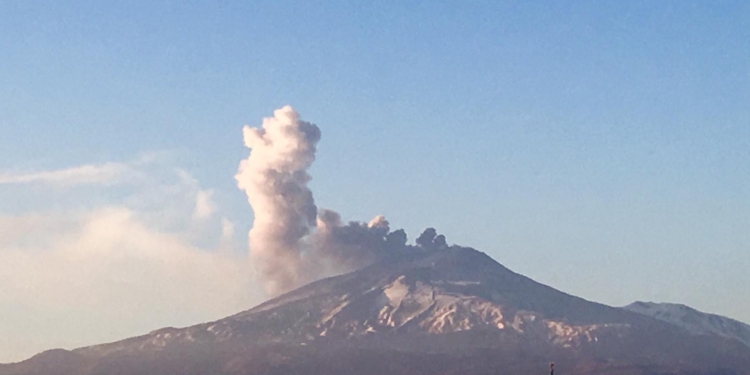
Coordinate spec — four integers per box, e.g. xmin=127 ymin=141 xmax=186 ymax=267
xmin=235 ymin=106 xmax=320 ymax=294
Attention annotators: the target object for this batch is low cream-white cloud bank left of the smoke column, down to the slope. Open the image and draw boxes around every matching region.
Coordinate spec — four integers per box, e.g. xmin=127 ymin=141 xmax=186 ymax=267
xmin=0 ymin=207 xmax=260 ymax=361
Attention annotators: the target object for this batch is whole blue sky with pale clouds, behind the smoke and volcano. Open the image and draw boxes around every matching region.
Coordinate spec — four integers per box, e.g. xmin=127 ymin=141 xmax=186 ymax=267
xmin=0 ymin=0 xmax=750 ymax=362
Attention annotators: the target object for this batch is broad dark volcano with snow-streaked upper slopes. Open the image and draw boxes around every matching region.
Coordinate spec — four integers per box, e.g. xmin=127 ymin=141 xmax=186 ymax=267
xmin=0 ymin=246 xmax=750 ymax=375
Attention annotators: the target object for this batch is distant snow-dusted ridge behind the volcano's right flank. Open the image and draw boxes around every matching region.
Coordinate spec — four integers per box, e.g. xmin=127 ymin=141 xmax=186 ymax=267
xmin=623 ymin=301 xmax=750 ymax=347
